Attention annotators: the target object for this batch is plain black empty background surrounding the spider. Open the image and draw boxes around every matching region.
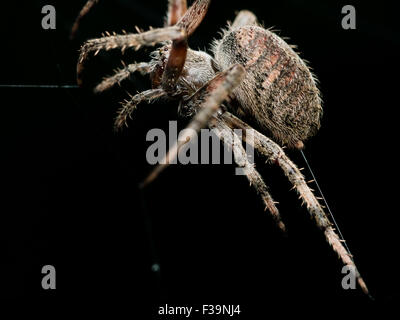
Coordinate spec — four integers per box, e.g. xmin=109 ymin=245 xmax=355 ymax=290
xmin=0 ymin=0 xmax=399 ymax=319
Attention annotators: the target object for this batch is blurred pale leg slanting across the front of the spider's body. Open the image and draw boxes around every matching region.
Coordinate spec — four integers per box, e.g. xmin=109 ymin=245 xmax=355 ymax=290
xmin=140 ymin=64 xmax=246 ymax=188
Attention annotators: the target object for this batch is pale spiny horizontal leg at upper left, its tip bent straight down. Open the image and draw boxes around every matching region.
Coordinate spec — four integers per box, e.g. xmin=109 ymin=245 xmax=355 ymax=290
xmin=77 ymin=26 xmax=186 ymax=85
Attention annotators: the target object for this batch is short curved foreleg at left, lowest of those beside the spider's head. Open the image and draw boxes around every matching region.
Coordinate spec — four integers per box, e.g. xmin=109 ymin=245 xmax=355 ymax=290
xmin=115 ymin=89 xmax=166 ymax=129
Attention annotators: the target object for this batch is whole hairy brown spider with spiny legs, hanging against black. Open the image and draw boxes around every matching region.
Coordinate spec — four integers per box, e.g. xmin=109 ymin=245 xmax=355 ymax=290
xmin=73 ymin=0 xmax=368 ymax=294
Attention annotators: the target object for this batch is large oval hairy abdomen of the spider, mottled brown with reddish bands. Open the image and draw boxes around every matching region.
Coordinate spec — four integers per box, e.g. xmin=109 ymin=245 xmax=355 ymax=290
xmin=214 ymin=26 xmax=322 ymax=147
